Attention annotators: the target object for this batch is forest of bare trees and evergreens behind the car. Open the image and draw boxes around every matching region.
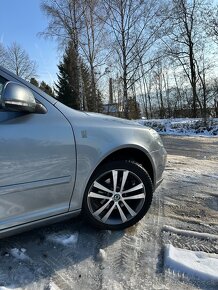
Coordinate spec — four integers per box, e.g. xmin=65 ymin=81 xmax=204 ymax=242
xmin=0 ymin=0 xmax=218 ymax=119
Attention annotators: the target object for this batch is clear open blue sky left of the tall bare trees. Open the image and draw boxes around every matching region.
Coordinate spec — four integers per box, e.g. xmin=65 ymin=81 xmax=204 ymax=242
xmin=0 ymin=0 xmax=60 ymax=85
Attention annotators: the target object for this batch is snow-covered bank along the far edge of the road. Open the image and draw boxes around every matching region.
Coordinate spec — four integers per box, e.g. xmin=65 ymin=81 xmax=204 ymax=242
xmin=137 ymin=118 xmax=218 ymax=137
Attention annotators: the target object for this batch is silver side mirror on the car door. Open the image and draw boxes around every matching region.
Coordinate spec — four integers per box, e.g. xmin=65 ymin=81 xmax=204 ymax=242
xmin=0 ymin=81 xmax=38 ymax=113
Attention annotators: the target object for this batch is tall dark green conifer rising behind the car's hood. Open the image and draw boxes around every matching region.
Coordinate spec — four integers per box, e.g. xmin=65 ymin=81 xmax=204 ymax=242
xmin=55 ymin=44 xmax=102 ymax=112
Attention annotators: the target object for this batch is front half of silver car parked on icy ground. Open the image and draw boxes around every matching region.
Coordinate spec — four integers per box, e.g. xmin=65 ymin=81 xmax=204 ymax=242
xmin=0 ymin=67 xmax=166 ymax=237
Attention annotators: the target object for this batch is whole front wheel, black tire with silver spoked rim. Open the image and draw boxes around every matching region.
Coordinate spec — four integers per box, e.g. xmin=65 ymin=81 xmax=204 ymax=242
xmin=83 ymin=160 xmax=153 ymax=230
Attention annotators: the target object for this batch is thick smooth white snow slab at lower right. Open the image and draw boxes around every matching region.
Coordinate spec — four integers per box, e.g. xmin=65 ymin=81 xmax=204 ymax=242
xmin=165 ymin=244 xmax=218 ymax=282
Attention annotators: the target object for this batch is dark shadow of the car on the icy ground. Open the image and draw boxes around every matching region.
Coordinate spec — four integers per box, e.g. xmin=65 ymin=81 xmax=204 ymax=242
xmin=0 ymin=216 xmax=124 ymax=289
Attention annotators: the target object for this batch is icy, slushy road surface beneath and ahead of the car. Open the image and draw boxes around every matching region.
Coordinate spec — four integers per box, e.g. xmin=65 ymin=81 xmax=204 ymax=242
xmin=0 ymin=136 xmax=218 ymax=290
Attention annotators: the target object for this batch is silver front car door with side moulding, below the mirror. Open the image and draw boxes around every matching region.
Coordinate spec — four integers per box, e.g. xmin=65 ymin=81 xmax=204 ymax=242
xmin=0 ymin=76 xmax=76 ymax=230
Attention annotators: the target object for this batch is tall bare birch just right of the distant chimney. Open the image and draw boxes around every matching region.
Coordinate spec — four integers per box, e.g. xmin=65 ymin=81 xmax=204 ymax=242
xmin=102 ymin=0 xmax=167 ymax=118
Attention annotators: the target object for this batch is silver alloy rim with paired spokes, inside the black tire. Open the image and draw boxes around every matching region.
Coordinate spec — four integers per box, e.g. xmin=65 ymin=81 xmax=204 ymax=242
xmin=86 ymin=164 xmax=147 ymax=226
